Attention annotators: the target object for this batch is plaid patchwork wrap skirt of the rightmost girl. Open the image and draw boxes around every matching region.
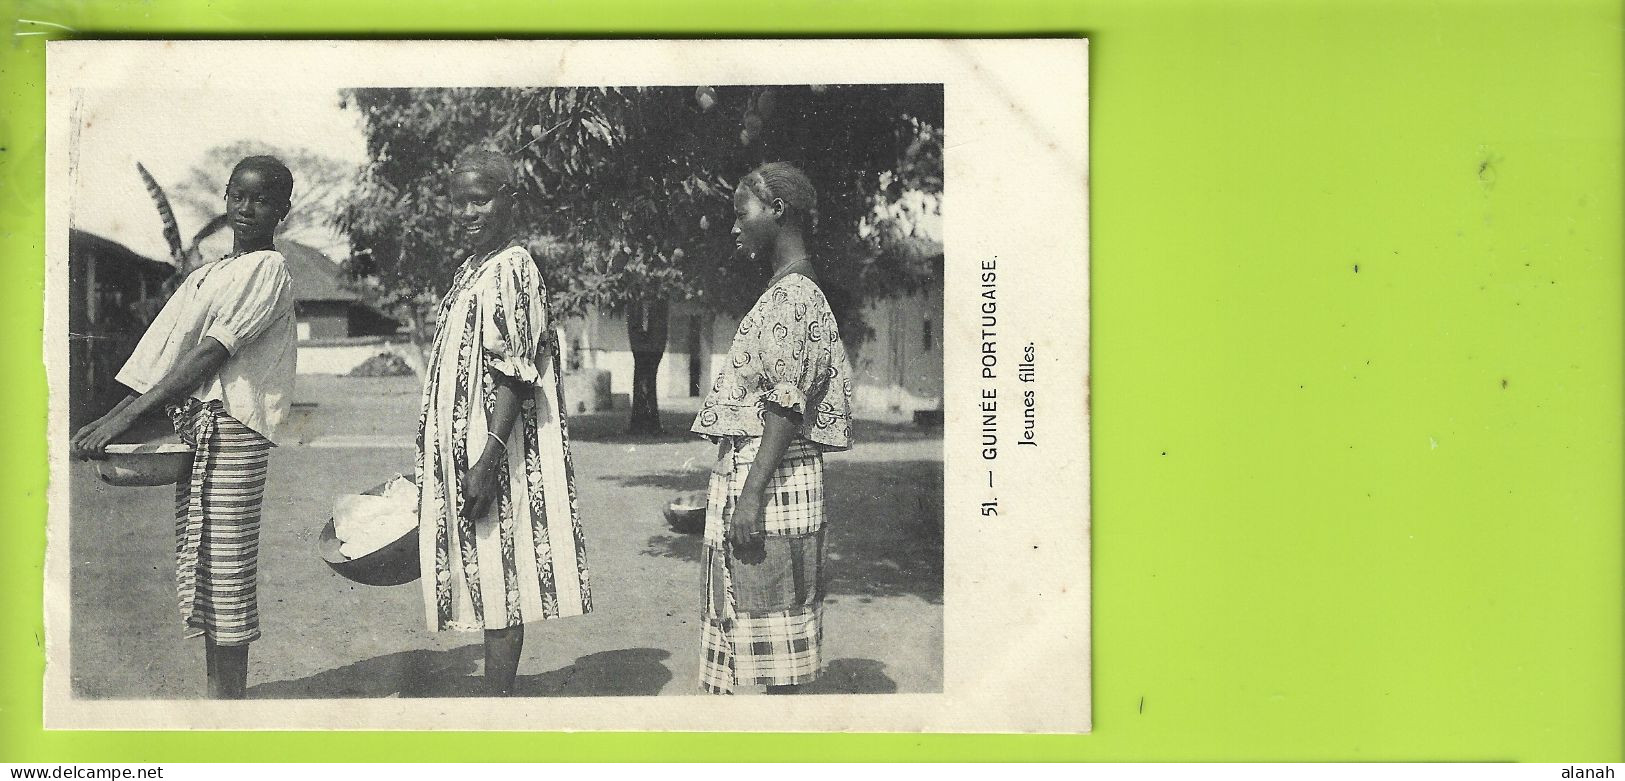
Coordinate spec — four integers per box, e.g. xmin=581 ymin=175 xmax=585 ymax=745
xmin=700 ymin=437 xmax=827 ymax=693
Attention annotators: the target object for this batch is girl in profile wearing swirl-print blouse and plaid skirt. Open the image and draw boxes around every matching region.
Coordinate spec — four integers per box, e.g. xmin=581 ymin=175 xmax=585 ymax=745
xmin=694 ymin=162 xmax=852 ymax=693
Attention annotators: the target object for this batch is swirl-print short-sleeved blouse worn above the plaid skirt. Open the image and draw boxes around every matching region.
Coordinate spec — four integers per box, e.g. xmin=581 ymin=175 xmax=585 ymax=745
xmin=692 ymin=274 xmax=852 ymax=450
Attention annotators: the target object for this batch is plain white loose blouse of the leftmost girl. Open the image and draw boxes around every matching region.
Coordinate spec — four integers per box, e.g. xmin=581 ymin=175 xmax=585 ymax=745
xmin=117 ymin=250 xmax=297 ymax=443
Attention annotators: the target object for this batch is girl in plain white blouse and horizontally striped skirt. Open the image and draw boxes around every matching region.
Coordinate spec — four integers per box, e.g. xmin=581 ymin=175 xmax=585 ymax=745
xmin=72 ymin=156 xmax=296 ymax=698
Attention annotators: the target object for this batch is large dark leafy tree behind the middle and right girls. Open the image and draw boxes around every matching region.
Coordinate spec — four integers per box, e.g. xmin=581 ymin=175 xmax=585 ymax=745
xmin=338 ymin=84 xmax=943 ymax=432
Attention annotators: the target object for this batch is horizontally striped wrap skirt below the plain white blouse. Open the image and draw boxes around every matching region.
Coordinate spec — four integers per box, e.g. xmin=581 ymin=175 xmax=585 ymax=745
xmin=169 ymin=399 xmax=271 ymax=646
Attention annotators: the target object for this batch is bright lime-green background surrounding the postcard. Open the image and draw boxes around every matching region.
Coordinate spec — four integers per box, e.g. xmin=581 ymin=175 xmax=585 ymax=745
xmin=0 ymin=0 xmax=1625 ymax=762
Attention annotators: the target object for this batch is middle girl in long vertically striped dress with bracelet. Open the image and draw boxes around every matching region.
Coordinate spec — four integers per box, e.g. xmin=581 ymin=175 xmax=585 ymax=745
xmin=418 ymin=151 xmax=592 ymax=697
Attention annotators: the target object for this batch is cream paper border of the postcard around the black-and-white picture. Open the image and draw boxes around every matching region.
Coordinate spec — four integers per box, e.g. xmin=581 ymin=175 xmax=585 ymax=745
xmin=46 ymin=39 xmax=1090 ymax=734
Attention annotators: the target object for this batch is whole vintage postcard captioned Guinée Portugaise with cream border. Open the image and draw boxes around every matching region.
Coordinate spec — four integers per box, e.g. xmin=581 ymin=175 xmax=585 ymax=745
xmin=46 ymin=39 xmax=1090 ymax=732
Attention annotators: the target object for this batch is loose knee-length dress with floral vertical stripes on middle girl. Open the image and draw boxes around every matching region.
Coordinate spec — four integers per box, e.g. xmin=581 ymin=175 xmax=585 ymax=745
xmin=418 ymin=247 xmax=593 ymax=632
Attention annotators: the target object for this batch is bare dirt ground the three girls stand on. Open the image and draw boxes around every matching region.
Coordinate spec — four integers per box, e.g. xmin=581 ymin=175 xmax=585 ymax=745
xmin=67 ymin=375 xmax=943 ymax=700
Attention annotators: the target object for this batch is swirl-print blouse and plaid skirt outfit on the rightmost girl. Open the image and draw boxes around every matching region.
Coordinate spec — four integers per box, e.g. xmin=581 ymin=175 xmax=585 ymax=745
xmin=692 ymin=274 xmax=852 ymax=693
